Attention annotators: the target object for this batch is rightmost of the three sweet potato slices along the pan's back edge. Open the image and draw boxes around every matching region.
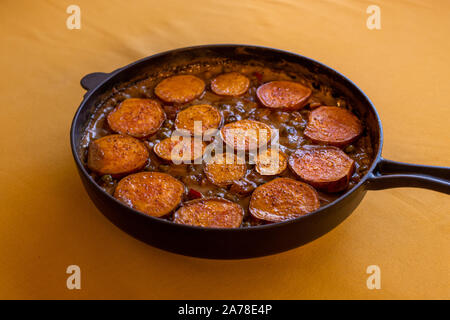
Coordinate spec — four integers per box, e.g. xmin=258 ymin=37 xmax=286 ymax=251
xmin=256 ymin=81 xmax=311 ymax=110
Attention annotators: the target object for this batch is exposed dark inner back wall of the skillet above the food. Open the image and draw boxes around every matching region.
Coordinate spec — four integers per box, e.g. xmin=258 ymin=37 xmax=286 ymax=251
xmin=73 ymin=46 xmax=381 ymax=228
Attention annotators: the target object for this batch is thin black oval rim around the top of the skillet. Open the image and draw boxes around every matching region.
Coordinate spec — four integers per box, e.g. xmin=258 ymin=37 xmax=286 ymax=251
xmin=70 ymin=44 xmax=383 ymax=233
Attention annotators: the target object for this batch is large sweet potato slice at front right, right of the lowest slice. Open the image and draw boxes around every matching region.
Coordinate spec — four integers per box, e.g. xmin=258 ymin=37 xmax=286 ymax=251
xmin=249 ymin=178 xmax=320 ymax=222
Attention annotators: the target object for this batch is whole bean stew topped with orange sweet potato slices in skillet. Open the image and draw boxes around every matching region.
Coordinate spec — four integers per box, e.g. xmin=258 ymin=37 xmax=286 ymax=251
xmin=84 ymin=62 xmax=373 ymax=228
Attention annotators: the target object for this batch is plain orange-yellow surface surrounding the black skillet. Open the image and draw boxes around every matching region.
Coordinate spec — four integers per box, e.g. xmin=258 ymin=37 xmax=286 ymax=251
xmin=0 ymin=0 xmax=450 ymax=299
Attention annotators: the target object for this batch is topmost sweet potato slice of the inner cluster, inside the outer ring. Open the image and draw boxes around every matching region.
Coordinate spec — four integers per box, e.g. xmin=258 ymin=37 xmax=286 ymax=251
xmin=175 ymin=104 xmax=222 ymax=135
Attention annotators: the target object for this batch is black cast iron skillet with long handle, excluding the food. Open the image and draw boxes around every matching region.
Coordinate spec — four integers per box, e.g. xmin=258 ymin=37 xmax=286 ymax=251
xmin=70 ymin=45 xmax=450 ymax=259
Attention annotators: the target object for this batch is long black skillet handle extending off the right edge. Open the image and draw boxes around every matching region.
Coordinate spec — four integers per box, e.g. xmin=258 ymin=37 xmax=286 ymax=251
xmin=367 ymin=158 xmax=450 ymax=194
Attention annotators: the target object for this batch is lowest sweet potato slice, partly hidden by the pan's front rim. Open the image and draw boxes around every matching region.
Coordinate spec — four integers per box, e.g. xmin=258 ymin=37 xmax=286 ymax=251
xmin=173 ymin=198 xmax=244 ymax=228
